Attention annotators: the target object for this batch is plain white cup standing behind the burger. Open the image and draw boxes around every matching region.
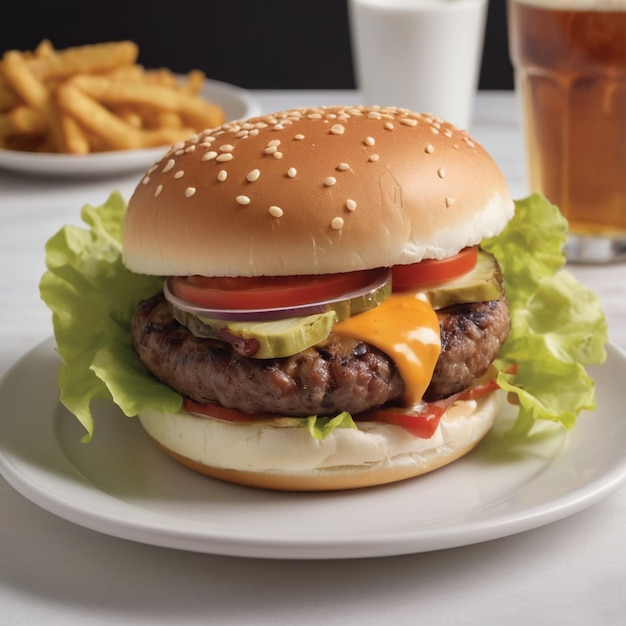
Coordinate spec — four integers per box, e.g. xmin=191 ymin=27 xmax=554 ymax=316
xmin=348 ymin=0 xmax=488 ymax=129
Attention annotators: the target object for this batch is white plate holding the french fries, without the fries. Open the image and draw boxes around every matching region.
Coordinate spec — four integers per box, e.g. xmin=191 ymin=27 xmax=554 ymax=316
xmin=0 ymin=80 xmax=261 ymax=177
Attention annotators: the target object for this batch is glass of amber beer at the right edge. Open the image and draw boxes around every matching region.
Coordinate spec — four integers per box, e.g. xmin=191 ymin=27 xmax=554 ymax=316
xmin=508 ymin=0 xmax=626 ymax=262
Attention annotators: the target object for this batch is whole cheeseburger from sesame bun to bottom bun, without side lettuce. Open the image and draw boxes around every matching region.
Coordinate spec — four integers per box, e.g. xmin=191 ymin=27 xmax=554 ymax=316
xmin=122 ymin=107 xmax=514 ymax=490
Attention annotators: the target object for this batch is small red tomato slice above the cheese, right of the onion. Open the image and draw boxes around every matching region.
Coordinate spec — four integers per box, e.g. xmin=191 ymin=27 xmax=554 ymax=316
xmin=391 ymin=246 xmax=478 ymax=291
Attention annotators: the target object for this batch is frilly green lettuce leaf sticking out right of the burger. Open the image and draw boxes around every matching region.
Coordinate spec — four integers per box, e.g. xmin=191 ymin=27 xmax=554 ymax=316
xmin=482 ymin=194 xmax=608 ymax=435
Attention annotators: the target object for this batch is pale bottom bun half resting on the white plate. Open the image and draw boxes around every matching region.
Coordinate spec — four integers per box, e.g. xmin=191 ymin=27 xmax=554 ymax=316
xmin=139 ymin=393 xmax=501 ymax=491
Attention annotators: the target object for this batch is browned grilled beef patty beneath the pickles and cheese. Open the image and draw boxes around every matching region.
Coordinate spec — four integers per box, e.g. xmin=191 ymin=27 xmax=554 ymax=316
xmin=132 ymin=294 xmax=510 ymax=417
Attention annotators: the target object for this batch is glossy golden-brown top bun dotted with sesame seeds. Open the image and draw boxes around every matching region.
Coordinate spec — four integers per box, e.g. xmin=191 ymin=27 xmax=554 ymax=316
xmin=123 ymin=106 xmax=513 ymax=276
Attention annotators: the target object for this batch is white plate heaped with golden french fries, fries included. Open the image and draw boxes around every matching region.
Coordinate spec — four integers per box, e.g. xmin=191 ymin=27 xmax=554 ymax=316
xmin=0 ymin=40 xmax=261 ymax=176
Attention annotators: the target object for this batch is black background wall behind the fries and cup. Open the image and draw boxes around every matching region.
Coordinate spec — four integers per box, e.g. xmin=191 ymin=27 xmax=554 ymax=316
xmin=0 ymin=0 xmax=513 ymax=89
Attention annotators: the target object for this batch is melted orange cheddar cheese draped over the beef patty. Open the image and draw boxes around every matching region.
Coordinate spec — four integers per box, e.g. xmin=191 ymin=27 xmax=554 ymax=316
xmin=333 ymin=293 xmax=441 ymax=406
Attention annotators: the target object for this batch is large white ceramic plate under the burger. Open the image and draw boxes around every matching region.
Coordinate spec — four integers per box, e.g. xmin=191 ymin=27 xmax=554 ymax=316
xmin=0 ymin=340 xmax=626 ymax=559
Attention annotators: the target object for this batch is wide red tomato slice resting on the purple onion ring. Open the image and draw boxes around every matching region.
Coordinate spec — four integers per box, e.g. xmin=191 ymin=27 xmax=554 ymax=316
xmin=170 ymin=269 xmax=379 ymax=310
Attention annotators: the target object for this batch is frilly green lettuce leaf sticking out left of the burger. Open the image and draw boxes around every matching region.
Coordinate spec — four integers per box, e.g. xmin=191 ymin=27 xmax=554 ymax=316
xmin=39 ymin=193 xmax=182 ymax=441
